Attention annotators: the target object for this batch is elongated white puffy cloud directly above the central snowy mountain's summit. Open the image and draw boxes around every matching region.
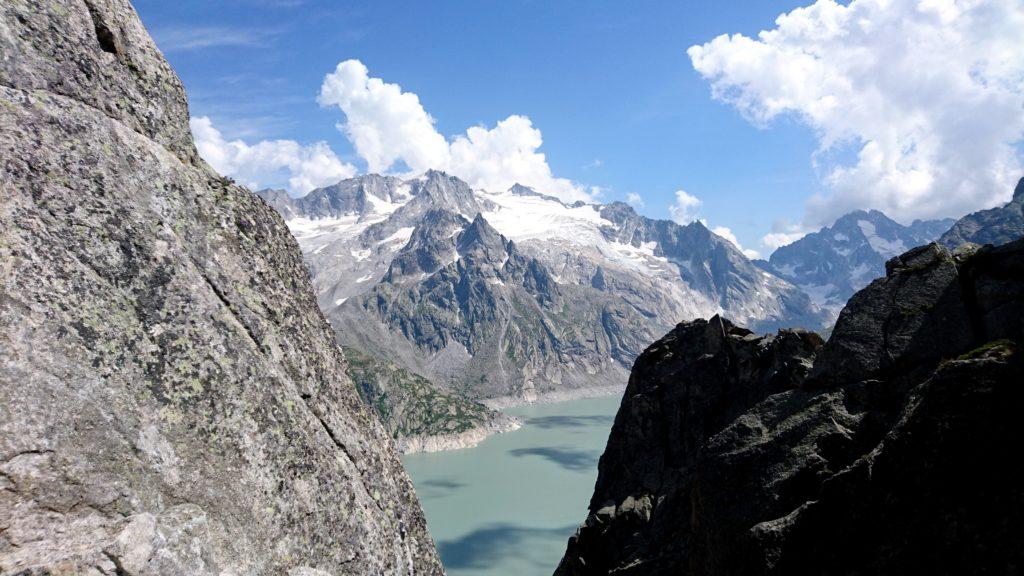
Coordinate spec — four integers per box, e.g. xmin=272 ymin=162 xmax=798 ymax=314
xmin=318 ymin=59 xmax=593 ymax=201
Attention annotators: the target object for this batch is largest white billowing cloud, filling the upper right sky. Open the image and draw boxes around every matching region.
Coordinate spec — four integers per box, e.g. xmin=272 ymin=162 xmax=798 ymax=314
xmin=688 ymin=0 xmax=1024 ymax=224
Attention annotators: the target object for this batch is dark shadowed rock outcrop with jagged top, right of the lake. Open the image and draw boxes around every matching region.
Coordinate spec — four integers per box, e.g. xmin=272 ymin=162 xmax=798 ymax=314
xmin=556 ymin=240 xmax=1024 ymax=575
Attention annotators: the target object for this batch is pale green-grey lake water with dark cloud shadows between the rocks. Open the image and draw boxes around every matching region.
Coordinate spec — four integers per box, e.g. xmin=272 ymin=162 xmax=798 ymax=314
xmin=402 ymin=396 xmax=621 ymax=576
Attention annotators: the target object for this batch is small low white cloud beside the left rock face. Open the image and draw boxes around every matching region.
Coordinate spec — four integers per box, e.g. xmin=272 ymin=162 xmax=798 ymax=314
xmin=189 ymin=116 xmax=356 ymax=194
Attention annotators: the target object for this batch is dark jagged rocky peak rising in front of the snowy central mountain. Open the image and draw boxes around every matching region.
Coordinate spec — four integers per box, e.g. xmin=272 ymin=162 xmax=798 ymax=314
xmin=331 ymin=211 xmax=650 ymax=401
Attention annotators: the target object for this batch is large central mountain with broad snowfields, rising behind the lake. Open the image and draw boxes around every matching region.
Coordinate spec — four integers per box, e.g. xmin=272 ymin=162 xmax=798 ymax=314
xmin=259 ymin=171 xmax=824 ymax=401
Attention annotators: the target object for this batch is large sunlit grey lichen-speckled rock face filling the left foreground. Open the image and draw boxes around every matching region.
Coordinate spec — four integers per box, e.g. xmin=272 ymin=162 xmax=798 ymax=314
xmin=0 ymin=0 xmax=441 ymax=575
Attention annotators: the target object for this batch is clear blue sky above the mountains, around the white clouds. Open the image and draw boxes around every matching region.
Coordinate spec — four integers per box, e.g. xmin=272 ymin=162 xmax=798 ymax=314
xmin=135 ymin=0 xmax=1019 ymax=252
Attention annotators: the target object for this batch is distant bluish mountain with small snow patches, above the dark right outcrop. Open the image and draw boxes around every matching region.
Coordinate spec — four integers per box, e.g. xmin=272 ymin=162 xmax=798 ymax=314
xmin=759 ymin=210 xmax=953 ymax=314
